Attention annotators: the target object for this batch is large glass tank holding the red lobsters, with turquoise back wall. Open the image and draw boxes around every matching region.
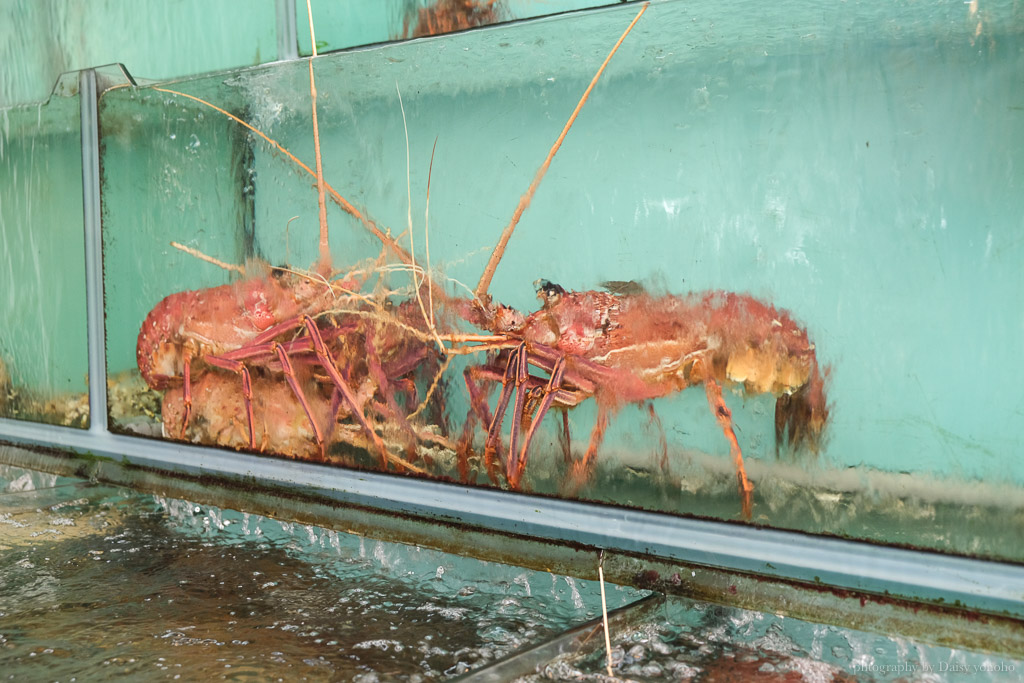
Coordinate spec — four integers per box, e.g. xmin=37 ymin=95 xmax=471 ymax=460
xmin=99 ymin=2 xmax=1024 ymax=561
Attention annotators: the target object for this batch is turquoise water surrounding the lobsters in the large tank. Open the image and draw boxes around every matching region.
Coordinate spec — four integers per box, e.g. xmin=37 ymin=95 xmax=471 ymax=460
xmin=90 ymin=2 xmax=1024 ymax=559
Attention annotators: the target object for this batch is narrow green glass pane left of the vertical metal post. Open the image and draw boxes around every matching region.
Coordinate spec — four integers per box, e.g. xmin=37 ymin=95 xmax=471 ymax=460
xmin=0 ymin=89 xmax=89 ymax=427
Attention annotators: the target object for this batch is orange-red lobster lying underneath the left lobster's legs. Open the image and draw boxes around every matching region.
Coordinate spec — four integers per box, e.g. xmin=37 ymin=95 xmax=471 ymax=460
xmin=155 ymin=305 xmax=446 ymax=473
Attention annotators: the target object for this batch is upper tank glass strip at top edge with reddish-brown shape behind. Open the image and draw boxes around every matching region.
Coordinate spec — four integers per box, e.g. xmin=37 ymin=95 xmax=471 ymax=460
xmin=295 ymin=0 xmax=610 ymax=56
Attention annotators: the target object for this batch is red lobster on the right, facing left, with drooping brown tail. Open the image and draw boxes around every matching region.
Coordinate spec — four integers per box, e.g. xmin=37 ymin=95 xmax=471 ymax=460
xmin=466 ymin=281 xmax=828 ymax=518
